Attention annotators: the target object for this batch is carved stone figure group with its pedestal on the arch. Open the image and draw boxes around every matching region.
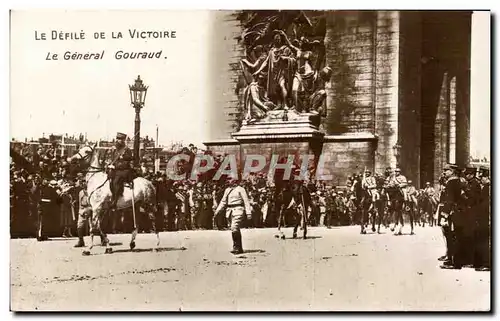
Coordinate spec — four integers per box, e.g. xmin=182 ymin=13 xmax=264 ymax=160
xmin=206 ymin=11 xmax=332 ymax=178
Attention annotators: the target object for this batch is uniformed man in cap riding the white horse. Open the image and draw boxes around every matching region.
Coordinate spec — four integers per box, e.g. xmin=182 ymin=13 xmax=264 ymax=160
xmin=107 ymin=133 xmax=134 ymax=208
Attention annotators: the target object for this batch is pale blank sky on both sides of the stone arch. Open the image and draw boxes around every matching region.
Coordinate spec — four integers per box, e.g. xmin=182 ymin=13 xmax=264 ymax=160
xmin=10 ymin=10 xmax=490 ymax=157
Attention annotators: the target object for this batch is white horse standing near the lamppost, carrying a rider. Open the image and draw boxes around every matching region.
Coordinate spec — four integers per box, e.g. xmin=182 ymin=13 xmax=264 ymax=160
xmin=68 ymin=144 xmax=160 ymax=255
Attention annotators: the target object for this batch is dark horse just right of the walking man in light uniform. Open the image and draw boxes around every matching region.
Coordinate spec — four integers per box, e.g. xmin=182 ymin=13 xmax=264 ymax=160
xmin=275 ymin=180 xmax=311 ymax=240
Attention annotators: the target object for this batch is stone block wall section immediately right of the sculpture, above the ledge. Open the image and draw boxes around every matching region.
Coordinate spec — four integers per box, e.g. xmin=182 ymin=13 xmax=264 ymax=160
xmin=324 ymin=11 xmax=375 ymax=135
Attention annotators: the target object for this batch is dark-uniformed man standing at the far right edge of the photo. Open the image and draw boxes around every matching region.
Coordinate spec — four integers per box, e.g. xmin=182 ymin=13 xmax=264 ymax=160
xmin=474 ymin=167 xmax=491 ymax=271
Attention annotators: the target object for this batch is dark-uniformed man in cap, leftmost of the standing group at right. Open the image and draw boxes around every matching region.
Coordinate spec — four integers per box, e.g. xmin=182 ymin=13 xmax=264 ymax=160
xmin=441 ymin=164 xmax=463 ymax=269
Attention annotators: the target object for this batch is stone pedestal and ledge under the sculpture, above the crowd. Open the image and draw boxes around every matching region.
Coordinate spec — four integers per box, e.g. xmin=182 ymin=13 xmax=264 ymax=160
xmin=205 ymin=118 xmax=377 ymax=186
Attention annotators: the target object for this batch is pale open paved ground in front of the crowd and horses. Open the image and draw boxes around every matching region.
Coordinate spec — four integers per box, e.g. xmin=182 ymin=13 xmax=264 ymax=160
xmin=11 ymin=227 xmax=490 ymax=311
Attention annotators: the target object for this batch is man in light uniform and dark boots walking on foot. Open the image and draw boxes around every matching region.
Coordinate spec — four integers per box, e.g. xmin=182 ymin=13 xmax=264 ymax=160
xmin=215 ymin=179 xmax=252 ymax=254
